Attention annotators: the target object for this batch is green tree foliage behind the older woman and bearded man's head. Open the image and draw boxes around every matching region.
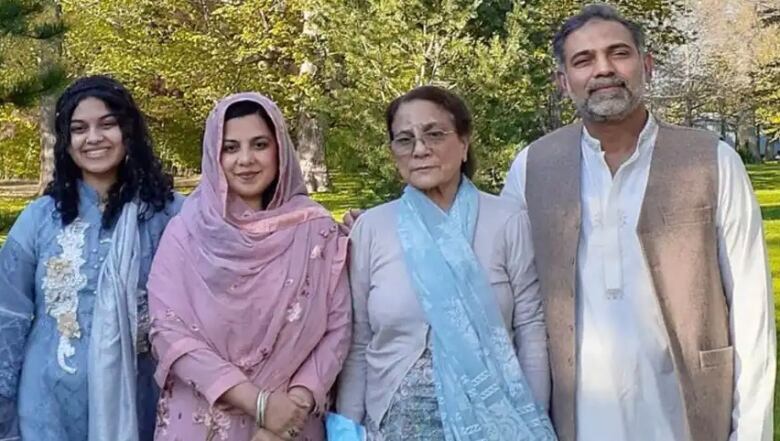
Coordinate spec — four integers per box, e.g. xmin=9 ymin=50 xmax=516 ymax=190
xmin=316 ymin=0 xmax=680 ymax=191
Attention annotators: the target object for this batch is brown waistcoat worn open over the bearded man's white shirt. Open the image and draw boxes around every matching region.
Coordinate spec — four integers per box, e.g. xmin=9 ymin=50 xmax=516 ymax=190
xmin=525 ymin=123 xmax=734 ymax=441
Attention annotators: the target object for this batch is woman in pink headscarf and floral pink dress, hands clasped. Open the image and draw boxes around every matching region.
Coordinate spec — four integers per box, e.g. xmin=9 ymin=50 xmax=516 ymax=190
xmin=148 ymin=93 xmax=351 ymax=441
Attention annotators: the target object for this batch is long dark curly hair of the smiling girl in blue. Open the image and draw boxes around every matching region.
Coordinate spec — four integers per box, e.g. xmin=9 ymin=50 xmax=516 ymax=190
xmin=44 ymin=75 xmax=173 ymax=228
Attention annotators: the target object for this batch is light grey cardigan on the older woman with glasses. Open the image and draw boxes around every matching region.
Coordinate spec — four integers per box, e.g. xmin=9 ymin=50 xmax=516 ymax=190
xmin=336 ymin=192 xmax=550 ymax=423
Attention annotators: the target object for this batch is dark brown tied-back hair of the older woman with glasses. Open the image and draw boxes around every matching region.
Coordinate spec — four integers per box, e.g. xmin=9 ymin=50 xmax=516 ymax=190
xmin=385 ymin=86 xmax=477 ymax=179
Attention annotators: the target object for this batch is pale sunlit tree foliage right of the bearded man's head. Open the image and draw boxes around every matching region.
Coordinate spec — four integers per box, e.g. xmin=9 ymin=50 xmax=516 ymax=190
xmin=654 ymin=0 xmax=780 ymax=157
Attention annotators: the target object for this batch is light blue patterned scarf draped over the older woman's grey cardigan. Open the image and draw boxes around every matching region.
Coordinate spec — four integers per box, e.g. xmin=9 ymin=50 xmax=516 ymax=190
xmin=398 ymin=176 xmax=556 ymax=441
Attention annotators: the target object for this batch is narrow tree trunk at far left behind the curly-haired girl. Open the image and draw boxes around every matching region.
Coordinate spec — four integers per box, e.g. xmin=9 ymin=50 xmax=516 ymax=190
xmin=38 ymin=0 xmax=62 ymax=195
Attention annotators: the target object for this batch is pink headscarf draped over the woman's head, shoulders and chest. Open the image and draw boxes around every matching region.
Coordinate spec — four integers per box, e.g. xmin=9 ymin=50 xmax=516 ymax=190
xmin=148 ymin=93 xmax=346 ymax=406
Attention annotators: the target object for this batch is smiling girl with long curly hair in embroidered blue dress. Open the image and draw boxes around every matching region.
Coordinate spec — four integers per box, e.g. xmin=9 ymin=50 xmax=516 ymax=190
xmin=0 ymin=76 xmax=180 ymax=441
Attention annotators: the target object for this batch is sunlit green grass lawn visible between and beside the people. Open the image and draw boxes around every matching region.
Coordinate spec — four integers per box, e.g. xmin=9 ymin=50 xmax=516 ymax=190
xmin=0 ymin=163 xmax=780 ymax=440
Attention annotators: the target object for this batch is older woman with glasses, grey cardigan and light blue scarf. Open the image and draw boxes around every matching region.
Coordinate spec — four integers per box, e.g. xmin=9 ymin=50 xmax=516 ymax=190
xmin=337 ymin=86 xmax=555 ymax=441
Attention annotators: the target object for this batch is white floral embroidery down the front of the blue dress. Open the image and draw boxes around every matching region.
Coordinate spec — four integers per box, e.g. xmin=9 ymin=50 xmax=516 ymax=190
xmin=42 ymin=218 xmax=88 ymax=374
